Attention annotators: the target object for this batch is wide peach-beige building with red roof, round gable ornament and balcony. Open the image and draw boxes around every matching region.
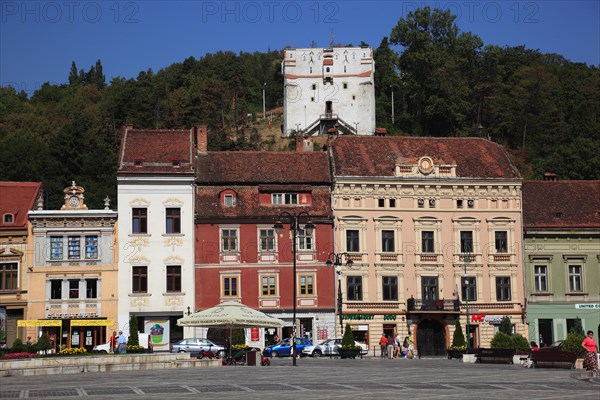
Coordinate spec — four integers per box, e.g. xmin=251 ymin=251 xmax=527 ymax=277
xmin=329 ymin=136 xmax=527 ymax=356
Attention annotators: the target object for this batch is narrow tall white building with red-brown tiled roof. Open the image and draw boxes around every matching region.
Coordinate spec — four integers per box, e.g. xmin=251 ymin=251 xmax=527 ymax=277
xmin=117 ymin=126 xmax=194 ymax=350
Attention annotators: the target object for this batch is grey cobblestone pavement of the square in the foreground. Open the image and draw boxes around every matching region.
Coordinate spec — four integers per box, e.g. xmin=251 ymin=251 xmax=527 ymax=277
xmin=0 ymin=358 xmax=600 ymax=400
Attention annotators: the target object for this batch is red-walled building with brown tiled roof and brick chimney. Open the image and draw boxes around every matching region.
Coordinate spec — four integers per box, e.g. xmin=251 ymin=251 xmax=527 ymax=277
xmin=195 ymin=129 xmax=335 ymax=341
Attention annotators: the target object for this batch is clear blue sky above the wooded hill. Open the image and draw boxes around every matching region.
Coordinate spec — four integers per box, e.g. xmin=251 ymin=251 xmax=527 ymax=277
xmin=0 ymin=0 xmax=600 ymax=94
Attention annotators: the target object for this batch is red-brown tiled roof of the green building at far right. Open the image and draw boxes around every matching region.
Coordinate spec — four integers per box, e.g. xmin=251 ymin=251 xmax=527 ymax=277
xmin=523 ymin=181 xmax=600 ymax=229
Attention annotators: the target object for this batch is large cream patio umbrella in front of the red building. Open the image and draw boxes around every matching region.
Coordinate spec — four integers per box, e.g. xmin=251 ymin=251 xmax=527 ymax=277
xmin=177 ymin=301 xmax=285 ymax=356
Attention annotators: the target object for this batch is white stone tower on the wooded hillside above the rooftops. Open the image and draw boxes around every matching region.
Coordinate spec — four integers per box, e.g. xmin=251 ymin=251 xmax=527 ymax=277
xmin=282 ymin=47 xmax=375 ymax=136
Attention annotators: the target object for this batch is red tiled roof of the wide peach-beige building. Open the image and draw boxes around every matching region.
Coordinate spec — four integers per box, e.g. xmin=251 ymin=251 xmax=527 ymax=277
xmin=330 ymin=136 xmax=521 ymax=179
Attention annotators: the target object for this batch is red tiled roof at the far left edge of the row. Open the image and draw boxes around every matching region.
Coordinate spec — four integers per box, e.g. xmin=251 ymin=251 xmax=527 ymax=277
xmin=0 ymin=182 xmax=42 ymax=230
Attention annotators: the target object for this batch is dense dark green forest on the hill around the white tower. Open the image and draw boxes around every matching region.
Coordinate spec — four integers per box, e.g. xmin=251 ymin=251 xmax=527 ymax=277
xmin=0 ymin=7 xmax=600 ymax=209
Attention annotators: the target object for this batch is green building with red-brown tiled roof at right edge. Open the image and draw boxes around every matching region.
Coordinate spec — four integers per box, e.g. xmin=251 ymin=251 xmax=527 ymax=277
xmin=523 ymin=180 xmax=600 ymax=346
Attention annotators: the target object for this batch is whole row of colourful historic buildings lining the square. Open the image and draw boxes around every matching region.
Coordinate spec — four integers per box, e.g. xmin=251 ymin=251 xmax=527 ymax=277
xmin=0 ymin=126 xmax=600 ymax=355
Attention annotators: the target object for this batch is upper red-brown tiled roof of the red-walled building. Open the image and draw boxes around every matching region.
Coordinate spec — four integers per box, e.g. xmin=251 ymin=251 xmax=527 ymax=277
xmin=196 ymin=151 xmax=331 ymax=185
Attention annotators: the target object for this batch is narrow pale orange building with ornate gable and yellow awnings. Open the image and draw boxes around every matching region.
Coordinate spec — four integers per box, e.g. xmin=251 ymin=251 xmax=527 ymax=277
xmin=26 ymin=182 xmax=118 ymax=351
